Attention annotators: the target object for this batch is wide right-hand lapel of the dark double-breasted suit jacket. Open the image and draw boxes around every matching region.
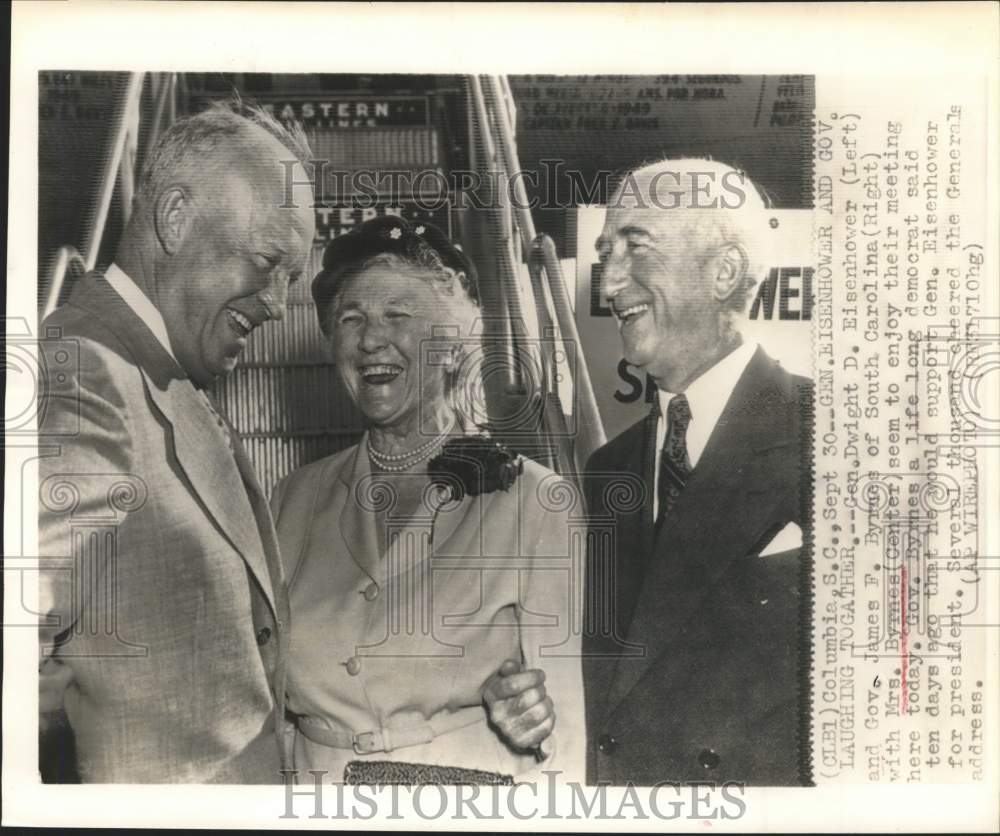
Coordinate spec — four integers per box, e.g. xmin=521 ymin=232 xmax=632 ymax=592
xmin=608 ymin=351 xmax=800 ymax=709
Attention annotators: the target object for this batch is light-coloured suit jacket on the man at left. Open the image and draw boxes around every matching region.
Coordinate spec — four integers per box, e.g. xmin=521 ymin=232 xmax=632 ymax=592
xmin=39 ymin=275 xmax=289 ymax=783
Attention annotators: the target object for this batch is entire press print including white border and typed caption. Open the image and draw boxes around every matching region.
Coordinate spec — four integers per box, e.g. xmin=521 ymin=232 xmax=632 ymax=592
xmin=4 ymin=3 xmax=1000 ymax=830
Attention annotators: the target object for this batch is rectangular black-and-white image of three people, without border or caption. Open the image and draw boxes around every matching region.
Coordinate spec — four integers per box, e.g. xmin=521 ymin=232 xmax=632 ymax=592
xmin=31 ymin=71 xmax=813 ymax=786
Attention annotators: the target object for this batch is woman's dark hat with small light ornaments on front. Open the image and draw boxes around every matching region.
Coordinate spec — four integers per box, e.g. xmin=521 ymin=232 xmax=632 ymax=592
xmin=312 ymin=215 xmax=479 ymax=334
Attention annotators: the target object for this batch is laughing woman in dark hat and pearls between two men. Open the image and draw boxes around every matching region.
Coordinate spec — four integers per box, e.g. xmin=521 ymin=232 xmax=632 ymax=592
xmin=272 ymin=217 xmax=584 ymax=783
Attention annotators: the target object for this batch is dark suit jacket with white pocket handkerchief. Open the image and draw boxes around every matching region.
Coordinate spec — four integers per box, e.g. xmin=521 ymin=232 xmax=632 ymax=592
xmin=583 ymin=349 xmax=811 ymax=786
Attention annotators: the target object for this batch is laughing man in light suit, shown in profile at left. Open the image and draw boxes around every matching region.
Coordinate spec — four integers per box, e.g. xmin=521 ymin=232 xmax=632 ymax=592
xmin=39 ymin=99 xmax=314 ymax=783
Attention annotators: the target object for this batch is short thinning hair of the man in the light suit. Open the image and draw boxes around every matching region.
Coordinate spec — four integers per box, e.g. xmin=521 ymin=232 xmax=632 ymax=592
xmin=136 ymin=96 xmax=312 ymax=207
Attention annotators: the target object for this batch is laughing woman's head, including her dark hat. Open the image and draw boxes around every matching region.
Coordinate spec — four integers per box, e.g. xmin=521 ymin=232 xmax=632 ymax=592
xmin=313 ymin=217 xmax=479 ymax=438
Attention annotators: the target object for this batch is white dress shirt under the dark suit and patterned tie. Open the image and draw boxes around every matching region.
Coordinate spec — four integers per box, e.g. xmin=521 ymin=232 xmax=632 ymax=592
xmin=653 ymin=340 xmax=757 ymax=520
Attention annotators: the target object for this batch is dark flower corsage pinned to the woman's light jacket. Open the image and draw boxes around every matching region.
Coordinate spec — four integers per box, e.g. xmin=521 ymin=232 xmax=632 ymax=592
xmin=427 ymin=435 xmax=524 ymax=502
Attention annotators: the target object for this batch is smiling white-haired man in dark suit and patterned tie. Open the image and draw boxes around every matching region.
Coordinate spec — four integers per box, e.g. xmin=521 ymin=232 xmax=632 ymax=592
xmin=584 ymin=160 xmax=809 ymax=786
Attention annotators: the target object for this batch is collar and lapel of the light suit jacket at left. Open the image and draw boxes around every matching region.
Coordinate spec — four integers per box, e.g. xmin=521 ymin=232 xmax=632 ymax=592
xmin=71 ymin=274 xmax=280 ymax=608
